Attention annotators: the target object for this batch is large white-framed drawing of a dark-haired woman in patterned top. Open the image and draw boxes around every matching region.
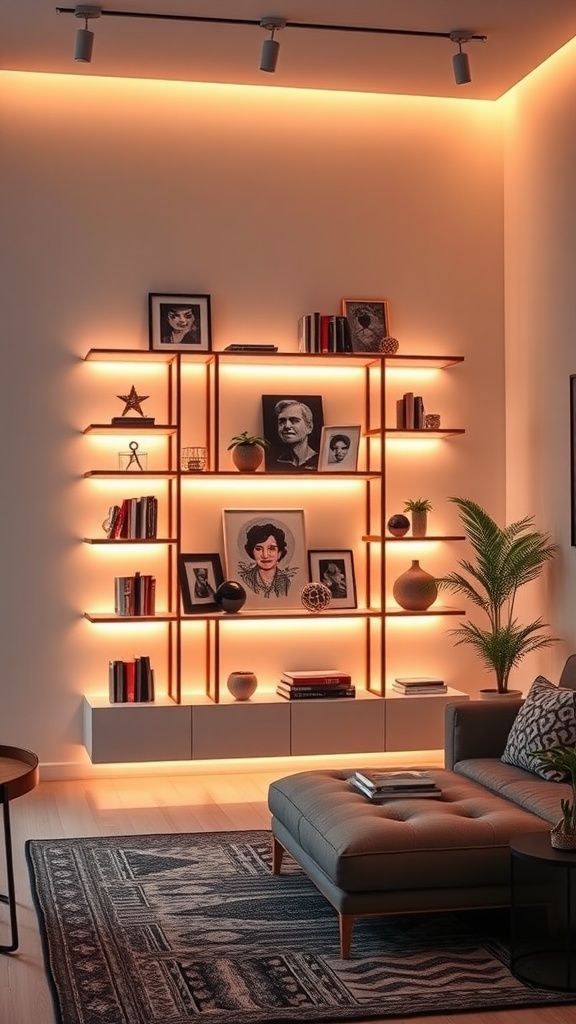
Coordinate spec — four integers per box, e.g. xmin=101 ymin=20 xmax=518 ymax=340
xmin=222 ymin=509 xmax=308 ymax=611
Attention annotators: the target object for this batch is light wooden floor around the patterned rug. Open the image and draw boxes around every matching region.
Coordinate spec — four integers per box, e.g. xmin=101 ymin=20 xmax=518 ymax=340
xmin=0 ymin=770 xmax=576 ymax=1024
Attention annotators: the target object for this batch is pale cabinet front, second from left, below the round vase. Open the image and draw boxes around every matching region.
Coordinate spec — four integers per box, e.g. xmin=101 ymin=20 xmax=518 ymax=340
xmin=192 ymin=701 xmax=290 ymax=761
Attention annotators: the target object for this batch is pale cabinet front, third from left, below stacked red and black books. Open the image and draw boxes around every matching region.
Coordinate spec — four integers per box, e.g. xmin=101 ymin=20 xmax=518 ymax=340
xmin=290 ymin=694 xmax=384 ymax=756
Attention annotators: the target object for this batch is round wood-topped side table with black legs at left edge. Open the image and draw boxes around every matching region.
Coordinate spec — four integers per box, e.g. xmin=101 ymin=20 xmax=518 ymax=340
xmin=0 ymin=744 xmax=40 ymax=953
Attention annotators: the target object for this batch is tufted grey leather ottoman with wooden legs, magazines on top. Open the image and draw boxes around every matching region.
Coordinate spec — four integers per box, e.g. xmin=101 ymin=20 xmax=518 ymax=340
xmin=269 ymin=768 xmax=549 ymax=958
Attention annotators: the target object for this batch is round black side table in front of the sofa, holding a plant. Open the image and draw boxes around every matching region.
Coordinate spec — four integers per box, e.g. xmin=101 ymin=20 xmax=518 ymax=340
xmin=510 ymin=831 xmax=576 ymax=992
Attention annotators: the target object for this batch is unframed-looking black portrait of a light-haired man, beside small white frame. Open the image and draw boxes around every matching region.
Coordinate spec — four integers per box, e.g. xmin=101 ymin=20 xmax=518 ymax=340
xmin=262 ymin=393 xmax=324 ymax=473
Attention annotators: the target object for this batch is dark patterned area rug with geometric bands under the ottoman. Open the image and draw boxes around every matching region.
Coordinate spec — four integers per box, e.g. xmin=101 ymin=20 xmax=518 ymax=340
xmin=27 ymin=831 xmax=574 ymax=1024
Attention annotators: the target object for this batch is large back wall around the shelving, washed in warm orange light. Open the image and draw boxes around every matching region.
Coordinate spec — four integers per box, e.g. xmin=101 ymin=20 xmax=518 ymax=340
xmin=0 ymin=73 xmax=502 ymax=764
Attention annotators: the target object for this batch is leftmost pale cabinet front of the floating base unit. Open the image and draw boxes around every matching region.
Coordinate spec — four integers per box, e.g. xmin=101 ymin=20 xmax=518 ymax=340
xmin=84 ymin=697 xmax=192 ymax=764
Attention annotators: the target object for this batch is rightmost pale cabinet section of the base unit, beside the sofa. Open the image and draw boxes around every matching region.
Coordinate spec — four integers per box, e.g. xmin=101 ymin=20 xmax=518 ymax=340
xmin=384 ymin=687 xmax=469 ymax=751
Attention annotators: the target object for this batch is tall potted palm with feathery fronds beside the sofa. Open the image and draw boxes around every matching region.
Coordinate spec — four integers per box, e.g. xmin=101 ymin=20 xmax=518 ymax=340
xmin=437 ymin=498 xmax=557 ymax=697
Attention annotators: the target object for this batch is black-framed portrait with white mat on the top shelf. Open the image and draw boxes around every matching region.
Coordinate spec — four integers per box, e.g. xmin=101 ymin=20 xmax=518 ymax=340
xmin=148 ymin=294 xmax=212 ymax=352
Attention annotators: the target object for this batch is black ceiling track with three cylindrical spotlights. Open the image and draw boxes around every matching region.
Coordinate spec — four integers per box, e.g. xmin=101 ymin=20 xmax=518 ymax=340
xmin=55 ymin=5 xmax=488 ymax=85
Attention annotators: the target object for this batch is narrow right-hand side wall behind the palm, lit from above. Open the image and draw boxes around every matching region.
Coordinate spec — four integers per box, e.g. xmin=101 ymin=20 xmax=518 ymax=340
xmin=499 ymin=41 xmax=576 ymax=680
